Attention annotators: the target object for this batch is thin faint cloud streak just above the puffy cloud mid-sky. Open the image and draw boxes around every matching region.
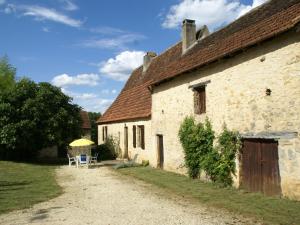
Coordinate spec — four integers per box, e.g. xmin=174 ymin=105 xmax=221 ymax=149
xmin=80 ymin=34 xmax=146 ymax=49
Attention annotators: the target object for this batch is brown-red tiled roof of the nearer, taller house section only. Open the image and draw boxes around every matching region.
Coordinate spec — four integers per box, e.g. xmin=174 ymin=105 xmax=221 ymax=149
xmin=152 ymin=0 xmax=300 ymax=84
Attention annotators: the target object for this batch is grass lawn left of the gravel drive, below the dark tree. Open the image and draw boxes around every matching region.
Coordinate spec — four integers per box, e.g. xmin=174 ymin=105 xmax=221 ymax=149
xmin=0 ymin=161 xmax=61 ymax=214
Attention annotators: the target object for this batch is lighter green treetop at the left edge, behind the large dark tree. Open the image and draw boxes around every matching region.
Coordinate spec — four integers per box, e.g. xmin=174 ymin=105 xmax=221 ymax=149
xmin=0 ymin=56 xmax=16 ymax=93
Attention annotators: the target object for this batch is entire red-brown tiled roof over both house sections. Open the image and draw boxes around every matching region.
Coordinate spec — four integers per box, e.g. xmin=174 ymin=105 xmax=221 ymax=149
xmin=98 ymin=0 xmax=300 ymax=123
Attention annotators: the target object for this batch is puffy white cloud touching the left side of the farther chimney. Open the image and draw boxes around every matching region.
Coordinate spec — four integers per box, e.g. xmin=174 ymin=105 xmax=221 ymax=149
xmin=99 ymin=51 xmax=145 ymax=81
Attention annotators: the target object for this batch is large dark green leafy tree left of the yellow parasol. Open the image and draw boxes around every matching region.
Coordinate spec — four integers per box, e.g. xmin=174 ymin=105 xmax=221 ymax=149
xmin=0 ymin=79 xmax=82 ymax=160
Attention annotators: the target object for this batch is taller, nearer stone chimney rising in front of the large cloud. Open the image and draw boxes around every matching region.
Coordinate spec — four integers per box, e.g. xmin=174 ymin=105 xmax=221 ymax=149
xmin=182 ymin=19 xmax=196 ymax=53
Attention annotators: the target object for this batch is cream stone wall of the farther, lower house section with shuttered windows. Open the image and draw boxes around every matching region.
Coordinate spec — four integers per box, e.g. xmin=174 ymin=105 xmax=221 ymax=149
xmin=98 ymin=119 xmax=156 ymax=165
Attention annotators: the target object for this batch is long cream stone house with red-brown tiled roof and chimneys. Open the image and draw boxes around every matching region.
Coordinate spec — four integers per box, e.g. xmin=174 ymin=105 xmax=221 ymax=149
xmin=98 ymin=0 xmax=300 ymax=199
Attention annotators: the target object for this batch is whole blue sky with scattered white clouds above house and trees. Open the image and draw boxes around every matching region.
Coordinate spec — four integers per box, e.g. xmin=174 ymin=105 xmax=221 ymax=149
xmin=0 ymin=0 xmax=265 ymax=112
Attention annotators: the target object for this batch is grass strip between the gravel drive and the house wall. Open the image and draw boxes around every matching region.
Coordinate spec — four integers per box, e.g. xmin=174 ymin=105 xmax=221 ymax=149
xmin=117 ymin=167 xmax=300 ymax=225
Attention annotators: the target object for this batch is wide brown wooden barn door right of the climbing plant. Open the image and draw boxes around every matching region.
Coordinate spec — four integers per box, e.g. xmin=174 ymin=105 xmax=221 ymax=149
xmin=241 ymin=139 xmax=281 ymax=195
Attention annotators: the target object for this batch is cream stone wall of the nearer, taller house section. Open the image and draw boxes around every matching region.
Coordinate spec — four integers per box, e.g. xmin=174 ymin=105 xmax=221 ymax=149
xmin=151 ymin=31 xmax=300 ymax=199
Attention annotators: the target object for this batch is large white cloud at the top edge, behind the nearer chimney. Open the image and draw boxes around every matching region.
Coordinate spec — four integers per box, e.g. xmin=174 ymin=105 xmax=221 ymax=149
xmin=162 ymin=0 xmax=266 ymax=30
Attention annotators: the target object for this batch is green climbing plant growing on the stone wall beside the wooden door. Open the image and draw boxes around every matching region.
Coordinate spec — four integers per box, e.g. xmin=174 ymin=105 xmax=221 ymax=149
xmin=179 ymin=116 xmax=240 ymax=186
